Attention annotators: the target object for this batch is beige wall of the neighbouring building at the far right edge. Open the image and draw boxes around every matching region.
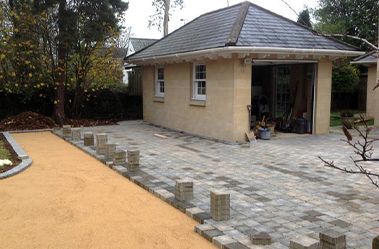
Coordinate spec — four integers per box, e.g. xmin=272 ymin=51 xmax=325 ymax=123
xmin=366 ymin=65 xmax=379 ymax=126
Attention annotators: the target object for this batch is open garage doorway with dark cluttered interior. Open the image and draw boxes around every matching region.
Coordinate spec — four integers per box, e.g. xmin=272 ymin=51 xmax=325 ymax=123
xmin=251 ymin=62 xmax=317 ymax=134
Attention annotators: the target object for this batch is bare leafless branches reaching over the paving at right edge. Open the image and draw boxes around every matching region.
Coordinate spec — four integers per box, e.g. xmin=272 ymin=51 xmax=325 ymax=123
xmin=319 ymin=116 xmax=379 ymax=188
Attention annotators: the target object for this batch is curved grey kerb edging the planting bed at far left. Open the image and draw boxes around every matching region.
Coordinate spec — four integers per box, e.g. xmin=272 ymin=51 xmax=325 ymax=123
xmin=0 ymin=132 xmax=33 ymax=179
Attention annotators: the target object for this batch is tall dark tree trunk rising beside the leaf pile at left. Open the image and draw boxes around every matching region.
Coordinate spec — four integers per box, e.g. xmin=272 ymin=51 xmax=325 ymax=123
xmin=54 ymin=0 xmax=67 ymax=125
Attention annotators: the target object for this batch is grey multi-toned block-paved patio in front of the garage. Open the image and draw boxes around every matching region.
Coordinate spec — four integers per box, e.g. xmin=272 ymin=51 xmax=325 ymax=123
xmin=84 ymin=121 xmax=379 ymax=249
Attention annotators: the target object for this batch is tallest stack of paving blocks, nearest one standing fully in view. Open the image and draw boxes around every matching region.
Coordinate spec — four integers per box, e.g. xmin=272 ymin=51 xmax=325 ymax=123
xmin=211 ymin=190 xmax=230 ymax=221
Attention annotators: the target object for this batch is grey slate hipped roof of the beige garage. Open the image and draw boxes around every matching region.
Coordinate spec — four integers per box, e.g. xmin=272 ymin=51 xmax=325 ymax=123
xmin=127 ymin=2 xmax=357 ymax=60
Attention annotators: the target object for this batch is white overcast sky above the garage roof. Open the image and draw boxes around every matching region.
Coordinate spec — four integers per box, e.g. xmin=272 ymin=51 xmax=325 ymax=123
xmin=125 ymin=0 xmax=317 ymax=38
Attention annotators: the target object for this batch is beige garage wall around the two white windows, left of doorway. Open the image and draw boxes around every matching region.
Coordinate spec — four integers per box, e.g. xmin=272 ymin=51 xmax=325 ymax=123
xmin=142 ymin=59 xmax=251 ymax=141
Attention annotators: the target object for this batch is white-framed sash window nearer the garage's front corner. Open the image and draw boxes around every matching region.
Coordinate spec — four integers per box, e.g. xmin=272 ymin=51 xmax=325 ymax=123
xmin=192 ymin=64 xmax=207 ymax=100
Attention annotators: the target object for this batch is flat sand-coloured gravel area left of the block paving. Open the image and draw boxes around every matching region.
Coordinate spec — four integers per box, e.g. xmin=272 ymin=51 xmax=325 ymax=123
xmin=0 ymin=132 xmax=215 ymax=249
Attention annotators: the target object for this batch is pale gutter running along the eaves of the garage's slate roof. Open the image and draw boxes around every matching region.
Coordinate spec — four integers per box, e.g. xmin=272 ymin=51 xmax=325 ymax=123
xmin=126 ymin=46 xmax=365 ymax=63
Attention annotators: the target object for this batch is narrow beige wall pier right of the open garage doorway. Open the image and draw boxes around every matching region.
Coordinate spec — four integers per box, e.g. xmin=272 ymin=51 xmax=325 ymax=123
xmin=314 ymin=60 xmax=332 ymax=135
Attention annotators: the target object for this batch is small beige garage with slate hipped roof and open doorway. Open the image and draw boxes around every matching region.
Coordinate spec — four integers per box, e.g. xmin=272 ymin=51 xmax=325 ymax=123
xmin=126 ymin=2 xmax=363 ymax=142
